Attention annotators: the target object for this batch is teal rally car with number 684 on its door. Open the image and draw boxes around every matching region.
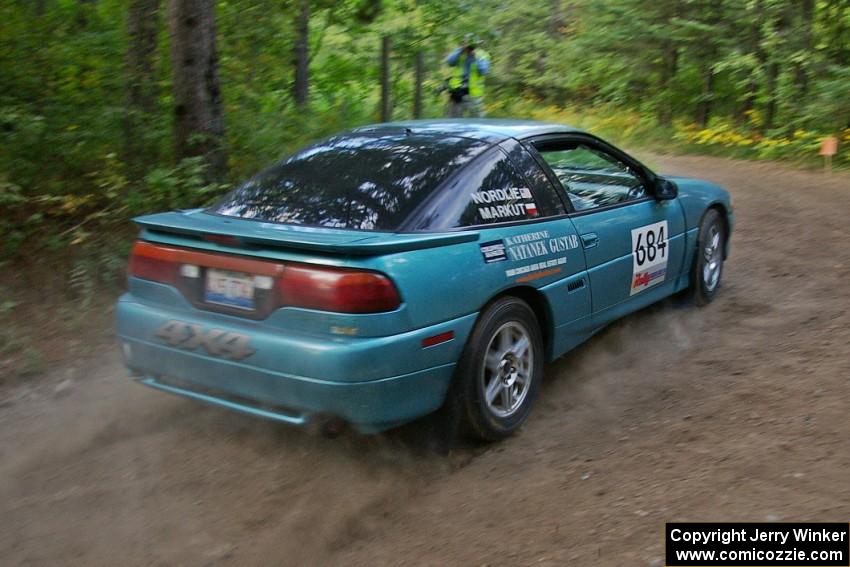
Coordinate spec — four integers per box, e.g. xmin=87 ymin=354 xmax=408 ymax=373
xmin=116 ymin=120 xmax=734 ymax=440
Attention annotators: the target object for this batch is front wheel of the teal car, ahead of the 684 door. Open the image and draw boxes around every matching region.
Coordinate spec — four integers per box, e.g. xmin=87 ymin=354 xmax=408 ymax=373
xmin=687 ymin=209 xmax=726 ymax=306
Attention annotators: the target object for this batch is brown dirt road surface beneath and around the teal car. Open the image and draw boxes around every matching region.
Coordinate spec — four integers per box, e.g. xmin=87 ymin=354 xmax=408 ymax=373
xmin=0 ymin=156 xmax=850 ymax=565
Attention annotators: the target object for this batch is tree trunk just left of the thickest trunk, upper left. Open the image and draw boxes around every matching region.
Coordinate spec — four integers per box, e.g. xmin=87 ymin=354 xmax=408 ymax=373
xmin=124 ymin=0 xmax=160 ymax=166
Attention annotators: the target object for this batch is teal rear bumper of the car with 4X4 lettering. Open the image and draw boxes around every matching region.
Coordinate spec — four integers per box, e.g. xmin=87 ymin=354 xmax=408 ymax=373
xmin=116 ymin=294 xmax=475 ymax=432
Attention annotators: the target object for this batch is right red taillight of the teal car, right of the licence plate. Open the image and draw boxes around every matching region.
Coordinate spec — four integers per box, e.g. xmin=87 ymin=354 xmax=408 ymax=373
xmin=278 ymin=264 xmax=401 ymax=313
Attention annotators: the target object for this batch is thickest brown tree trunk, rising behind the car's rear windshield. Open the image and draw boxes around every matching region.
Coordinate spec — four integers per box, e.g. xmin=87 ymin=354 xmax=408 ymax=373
xmin=168 ymin=0 xmax=227 ymax=181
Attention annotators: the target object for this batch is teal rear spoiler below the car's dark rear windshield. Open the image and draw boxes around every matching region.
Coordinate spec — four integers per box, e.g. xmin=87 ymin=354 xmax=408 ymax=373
xmin=133 ymin=209 xmax=479 ymax=256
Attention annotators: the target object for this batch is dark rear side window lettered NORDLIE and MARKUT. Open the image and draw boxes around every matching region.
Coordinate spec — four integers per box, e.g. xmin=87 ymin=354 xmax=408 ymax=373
xmin=400 ymin=147 xmax=563 ymax=234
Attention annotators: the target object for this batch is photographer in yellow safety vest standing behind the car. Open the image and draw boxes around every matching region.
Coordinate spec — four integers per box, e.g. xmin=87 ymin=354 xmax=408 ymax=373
xmin=445 ymin=35 xmax=490 ymax=118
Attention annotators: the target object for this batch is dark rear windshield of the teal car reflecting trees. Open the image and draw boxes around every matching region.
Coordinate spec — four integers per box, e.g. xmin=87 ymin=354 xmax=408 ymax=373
xmin=209 ymin=132 xmax=487 ymax=231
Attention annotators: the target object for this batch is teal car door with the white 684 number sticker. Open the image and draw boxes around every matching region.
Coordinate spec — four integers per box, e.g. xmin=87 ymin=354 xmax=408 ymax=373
xmin=531 ymin=135 xmax=685 ymax=325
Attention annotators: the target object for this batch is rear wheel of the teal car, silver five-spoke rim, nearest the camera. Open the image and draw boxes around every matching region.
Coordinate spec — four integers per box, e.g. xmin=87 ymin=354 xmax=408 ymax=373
xmin=447 ymin=296 xmax=544 ymax=441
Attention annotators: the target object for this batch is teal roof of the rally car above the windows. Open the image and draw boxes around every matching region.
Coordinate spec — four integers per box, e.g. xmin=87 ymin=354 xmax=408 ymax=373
xmin=351 ymin=118 xmax=583 ymax=143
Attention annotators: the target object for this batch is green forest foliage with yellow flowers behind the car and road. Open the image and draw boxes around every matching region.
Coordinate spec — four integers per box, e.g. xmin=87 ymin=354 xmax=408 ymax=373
xmin=0 ymin=0 xmax=850 ymax=268
